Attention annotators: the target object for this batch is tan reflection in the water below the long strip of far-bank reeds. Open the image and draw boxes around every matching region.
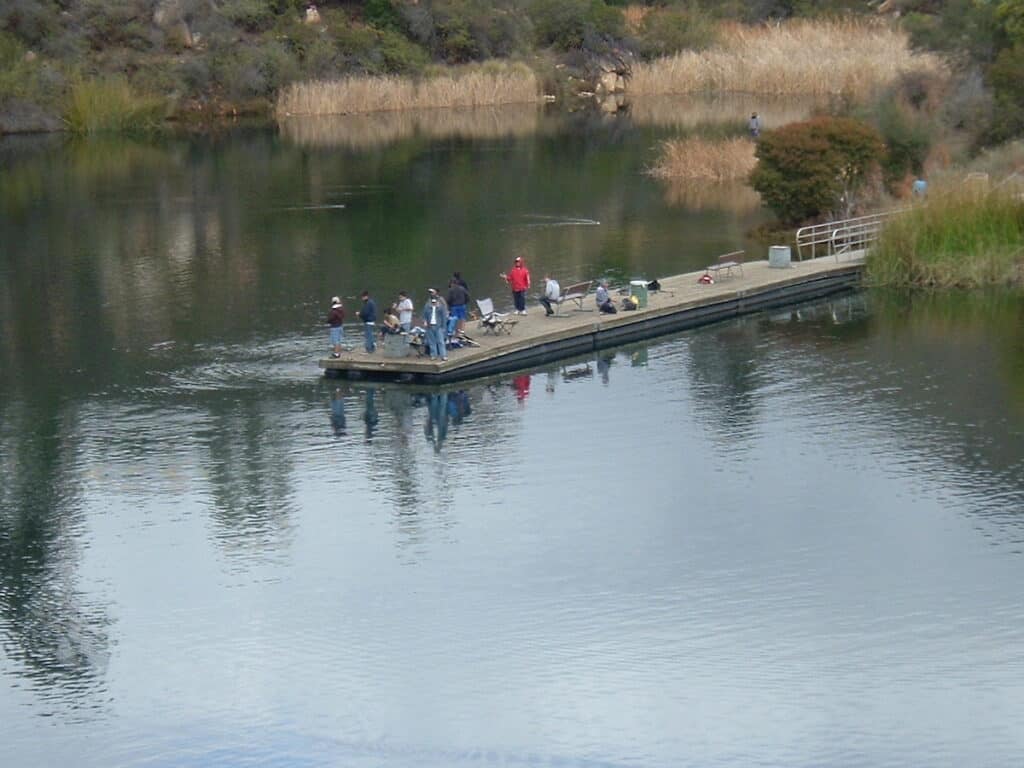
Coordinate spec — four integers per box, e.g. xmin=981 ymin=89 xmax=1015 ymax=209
xmin=279 ymin=104 xmax=541 ymax=150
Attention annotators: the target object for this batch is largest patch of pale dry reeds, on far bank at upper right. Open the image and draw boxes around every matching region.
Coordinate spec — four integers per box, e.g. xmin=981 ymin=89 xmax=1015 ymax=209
xmin=629 ymin=20 xmax=946 ymax=99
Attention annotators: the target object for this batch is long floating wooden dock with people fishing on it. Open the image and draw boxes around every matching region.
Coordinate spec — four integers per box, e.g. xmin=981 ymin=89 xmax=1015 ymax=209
xmin=319 ymin=253 xmax=863 ymax=384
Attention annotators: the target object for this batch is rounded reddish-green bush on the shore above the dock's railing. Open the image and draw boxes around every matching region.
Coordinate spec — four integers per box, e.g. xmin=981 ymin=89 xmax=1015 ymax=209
xmin=751 ymin=117 xmax=886 ymax=224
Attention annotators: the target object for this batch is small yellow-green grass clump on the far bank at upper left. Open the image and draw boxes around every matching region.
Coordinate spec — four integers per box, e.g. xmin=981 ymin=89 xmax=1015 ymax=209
xmin=65 ymin=78 xmax=167 ymax=133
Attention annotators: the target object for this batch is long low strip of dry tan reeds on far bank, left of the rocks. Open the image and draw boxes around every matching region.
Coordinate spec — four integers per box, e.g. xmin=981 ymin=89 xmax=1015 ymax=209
xmin=276 ymin=65 xmax=541 ymax=117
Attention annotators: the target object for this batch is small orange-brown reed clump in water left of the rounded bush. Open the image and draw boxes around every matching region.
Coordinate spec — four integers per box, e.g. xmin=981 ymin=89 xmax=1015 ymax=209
xmin=647 ymin=137 xmax=757 ymax=182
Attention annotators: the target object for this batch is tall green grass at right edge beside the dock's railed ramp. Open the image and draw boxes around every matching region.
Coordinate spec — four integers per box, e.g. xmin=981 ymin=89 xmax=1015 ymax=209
xmin=865 ymin=184 xmax=1024 ymax=288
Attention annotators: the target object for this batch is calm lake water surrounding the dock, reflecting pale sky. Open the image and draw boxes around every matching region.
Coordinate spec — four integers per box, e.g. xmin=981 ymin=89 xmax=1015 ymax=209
xmin=0 ymin=103 xmax=1024 ymax=768
